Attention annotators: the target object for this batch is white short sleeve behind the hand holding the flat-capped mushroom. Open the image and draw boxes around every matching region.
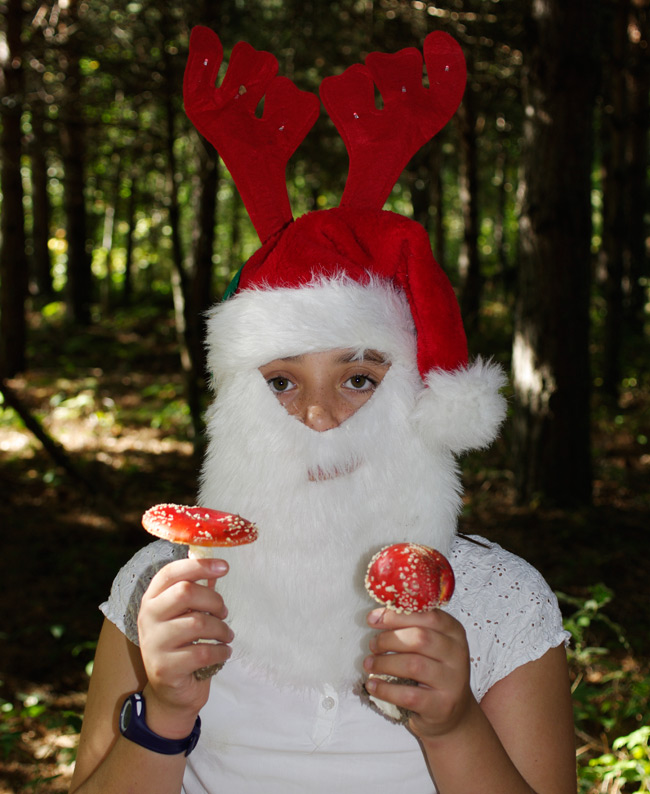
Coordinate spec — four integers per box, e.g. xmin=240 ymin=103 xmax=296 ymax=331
xmin=99 ymin=540 xmax=187 ymax=645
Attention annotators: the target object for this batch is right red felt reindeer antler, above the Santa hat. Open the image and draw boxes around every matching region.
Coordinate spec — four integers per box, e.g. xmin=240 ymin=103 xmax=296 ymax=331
xmin=320 ymin=31 xmax=467 ymax=209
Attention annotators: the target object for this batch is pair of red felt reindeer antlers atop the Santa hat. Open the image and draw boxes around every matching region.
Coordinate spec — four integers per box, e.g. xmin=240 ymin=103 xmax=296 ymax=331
xmin=183 ymin=27 xmax=466 ymax=242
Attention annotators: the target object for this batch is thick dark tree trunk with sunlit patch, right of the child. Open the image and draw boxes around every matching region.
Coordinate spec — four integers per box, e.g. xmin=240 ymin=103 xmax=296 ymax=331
xmin=513 ymin=0 xmax=600 ymax=507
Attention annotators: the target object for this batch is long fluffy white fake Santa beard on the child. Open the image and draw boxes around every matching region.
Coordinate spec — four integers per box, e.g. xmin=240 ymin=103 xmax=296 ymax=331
xmin=200 ymin=363 xmax=460 ymax=688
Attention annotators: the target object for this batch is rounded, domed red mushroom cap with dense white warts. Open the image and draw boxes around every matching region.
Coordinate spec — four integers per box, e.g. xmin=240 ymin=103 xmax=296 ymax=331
xmin=365 ymin=543 xmax=455 ymax=614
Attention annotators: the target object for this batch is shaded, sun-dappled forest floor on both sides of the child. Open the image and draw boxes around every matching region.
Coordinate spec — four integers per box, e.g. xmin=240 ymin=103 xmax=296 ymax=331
xmin=0 ymin=302 xmax=650 ymax=794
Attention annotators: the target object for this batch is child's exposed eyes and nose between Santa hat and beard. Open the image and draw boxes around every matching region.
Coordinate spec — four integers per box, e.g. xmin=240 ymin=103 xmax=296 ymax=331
xmin=259 ymin=349 xmax=390 ymax=432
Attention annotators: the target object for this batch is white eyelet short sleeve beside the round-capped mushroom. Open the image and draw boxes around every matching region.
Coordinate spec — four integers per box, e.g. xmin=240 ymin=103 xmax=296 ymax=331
xmin=449 ymin=538 xmax=570 ymax=700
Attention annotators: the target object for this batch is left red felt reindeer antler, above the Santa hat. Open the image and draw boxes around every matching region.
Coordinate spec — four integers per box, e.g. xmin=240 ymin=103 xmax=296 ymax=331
xmin=183 ymin=26 xmax=320 ymax=242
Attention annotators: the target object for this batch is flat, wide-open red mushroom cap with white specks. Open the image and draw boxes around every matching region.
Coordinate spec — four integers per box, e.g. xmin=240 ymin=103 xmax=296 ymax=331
xmin=142 ymin=504 xmax=257 ymax=546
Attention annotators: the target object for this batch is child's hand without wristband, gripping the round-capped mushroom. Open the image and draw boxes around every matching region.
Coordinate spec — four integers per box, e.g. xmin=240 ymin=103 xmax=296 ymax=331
xmin=364 ymin=609 xmax=473 ymax=738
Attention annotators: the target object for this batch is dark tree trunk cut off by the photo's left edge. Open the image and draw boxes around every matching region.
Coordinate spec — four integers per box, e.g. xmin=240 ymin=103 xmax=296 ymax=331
xmin=0 ymin=0 xmax=28 ymax=377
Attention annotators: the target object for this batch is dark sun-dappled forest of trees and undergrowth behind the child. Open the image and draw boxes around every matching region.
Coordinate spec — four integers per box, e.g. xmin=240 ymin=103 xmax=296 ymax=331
xmin=0 ymin=0 xmax=650 ymax=794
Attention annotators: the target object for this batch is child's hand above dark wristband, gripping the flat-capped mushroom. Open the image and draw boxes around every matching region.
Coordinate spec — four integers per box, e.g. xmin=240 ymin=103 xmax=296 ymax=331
xmin=138 ymin=559 xmax=233 ymax=738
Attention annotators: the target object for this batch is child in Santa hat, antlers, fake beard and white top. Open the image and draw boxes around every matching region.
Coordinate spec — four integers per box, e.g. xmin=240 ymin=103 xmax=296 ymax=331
xmin=71 ymin=24 xmax=576 ymax=794
